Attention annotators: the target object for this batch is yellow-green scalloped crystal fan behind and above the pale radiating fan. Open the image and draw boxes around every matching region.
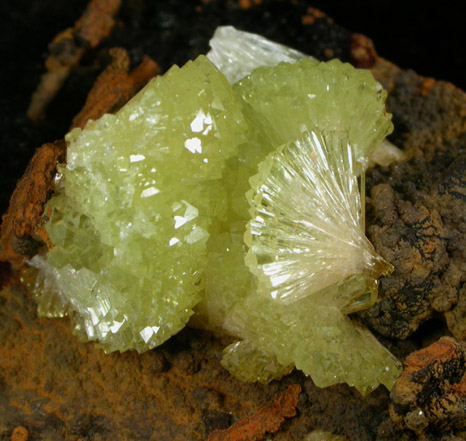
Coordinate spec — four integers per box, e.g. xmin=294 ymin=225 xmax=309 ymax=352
xmin=235 ymin=58 xmax=393 ymax=166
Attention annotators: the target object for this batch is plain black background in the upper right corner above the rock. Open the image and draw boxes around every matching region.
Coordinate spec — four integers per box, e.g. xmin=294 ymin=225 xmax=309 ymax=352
xmin=312 ymin=0 xmax=466 ymax=90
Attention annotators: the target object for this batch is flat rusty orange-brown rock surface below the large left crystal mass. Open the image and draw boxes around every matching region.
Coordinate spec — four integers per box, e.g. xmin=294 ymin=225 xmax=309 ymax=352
xmin=0 ymin=277 xmax=310 ymax=441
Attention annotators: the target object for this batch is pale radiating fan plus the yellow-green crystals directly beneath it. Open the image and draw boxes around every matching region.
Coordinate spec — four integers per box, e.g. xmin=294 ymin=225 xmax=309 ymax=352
xmin=197 ymin=132 xmax=400 ymax=394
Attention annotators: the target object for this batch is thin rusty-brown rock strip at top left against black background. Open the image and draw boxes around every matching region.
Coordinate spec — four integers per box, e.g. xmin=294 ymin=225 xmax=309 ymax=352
xmin=27 ymin=0 xmax=121 ymax=121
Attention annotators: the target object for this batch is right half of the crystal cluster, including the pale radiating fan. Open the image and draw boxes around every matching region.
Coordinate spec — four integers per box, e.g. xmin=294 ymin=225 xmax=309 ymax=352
xmin=193 ymin=54 xmax=400 ymax=393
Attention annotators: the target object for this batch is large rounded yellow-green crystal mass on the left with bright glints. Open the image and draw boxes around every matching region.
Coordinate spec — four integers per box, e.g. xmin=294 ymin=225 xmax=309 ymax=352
xmin=33 ymin=56 xmax=247 ymax=351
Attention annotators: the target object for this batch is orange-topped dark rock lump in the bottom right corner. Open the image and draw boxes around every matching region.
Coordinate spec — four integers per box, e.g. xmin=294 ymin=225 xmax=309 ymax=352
xmin=390 ymin=337 xmax=466 ymax=433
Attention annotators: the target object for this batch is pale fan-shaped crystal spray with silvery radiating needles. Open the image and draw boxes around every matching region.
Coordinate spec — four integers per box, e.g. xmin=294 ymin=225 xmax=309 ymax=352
xmin=245 ymin=132 xmax=391 ymax=309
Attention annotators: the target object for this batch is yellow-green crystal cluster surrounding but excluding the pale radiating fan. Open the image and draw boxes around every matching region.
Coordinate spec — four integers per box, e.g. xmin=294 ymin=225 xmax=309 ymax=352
xmin=32 ymin=56 xmax=399 ymax=393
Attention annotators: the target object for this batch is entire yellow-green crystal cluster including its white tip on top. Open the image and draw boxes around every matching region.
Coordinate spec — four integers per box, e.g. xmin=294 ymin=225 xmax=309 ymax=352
xmin=31 ymin=27 xmax=400 ymax=393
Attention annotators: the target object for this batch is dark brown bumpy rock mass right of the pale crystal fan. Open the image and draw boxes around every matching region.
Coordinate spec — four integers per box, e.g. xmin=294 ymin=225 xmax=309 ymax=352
xmin=361 ymin=59 xmax=466 ymax=339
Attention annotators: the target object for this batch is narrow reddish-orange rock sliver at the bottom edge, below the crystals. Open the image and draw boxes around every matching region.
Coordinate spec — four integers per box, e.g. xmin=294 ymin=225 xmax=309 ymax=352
xmin=207 ymin=384 xmax=301 ymax=441
